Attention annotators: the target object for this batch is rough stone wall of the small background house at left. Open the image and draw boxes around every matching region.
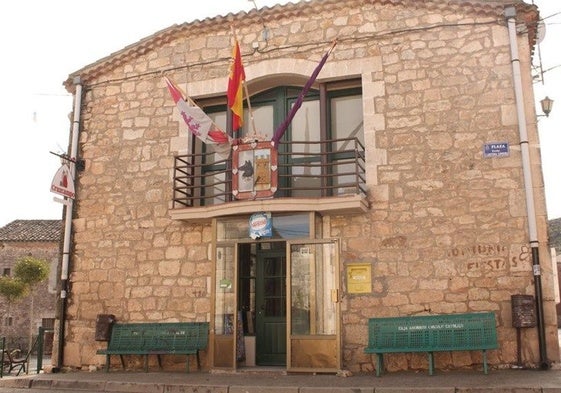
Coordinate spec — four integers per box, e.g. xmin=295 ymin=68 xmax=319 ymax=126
xmin=0 ymin=242 xmax=59 ymax=350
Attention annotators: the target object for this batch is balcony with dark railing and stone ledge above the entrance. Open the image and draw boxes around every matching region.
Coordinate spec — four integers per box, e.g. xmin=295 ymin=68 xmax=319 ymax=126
xmin=171 ymin=138 xmax=369 ymax=220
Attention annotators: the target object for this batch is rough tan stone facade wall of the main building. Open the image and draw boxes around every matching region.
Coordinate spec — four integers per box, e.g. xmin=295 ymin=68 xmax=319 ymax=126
xmin=65 ymin=2 xmax=558 ymax=371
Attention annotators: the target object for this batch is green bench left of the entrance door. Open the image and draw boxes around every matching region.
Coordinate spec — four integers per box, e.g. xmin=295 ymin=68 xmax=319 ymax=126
xmin=97 ymin=322 xmax=209 ymax=372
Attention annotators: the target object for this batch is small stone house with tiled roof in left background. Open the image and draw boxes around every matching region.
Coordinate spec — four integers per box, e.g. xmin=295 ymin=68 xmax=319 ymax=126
xmin=0 ymin=220 xmax=62 ymax=349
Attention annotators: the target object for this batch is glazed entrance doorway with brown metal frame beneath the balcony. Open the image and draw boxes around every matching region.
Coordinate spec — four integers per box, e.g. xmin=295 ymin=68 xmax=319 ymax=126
xmin=212 ymin=234 xmax=341 ymax=372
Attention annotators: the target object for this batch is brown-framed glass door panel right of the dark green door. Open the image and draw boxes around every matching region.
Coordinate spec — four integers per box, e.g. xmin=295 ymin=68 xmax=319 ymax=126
xmin=287 ymin=240 xmax=341 ymax=372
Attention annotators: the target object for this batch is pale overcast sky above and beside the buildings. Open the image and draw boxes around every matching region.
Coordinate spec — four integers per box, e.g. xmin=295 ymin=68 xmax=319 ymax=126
xmin=0 ymin=0 xmax=561 ymax=226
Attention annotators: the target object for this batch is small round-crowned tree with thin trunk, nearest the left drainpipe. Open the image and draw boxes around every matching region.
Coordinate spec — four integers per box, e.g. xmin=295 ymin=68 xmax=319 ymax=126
xmin=14 ymin=256 xmax=49 ymax=351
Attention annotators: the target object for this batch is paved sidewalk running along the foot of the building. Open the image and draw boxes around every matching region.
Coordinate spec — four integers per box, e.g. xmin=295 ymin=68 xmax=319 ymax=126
xmin=0 ymin=369 xmax=561 ymax=393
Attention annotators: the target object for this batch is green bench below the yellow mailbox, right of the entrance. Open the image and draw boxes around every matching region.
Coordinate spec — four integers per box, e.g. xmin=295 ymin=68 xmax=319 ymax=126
xmin=364 ymin=312 xmax=498 ymax=377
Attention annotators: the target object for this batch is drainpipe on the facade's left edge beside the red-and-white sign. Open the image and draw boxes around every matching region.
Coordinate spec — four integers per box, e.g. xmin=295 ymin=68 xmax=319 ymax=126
xmin=53 ymin=76 xmax=82 ymax=371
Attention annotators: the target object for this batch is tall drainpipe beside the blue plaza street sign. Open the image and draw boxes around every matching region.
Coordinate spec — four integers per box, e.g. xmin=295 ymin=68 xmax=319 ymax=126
xmin=505 ymin=7 xmax=551 ymax=370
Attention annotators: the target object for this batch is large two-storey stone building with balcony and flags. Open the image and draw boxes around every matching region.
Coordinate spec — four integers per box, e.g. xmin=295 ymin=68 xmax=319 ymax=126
xmin=57 ymin=0 xmax=559 ymax=372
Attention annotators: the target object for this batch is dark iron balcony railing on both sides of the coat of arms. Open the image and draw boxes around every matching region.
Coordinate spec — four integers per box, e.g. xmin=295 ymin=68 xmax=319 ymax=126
xmin=173 ymin=138 xmax=366 ymax=209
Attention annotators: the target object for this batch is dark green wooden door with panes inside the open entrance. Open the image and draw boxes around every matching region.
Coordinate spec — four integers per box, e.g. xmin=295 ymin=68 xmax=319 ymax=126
xmin=255 ymin=249 xmax=286 ymax=366
